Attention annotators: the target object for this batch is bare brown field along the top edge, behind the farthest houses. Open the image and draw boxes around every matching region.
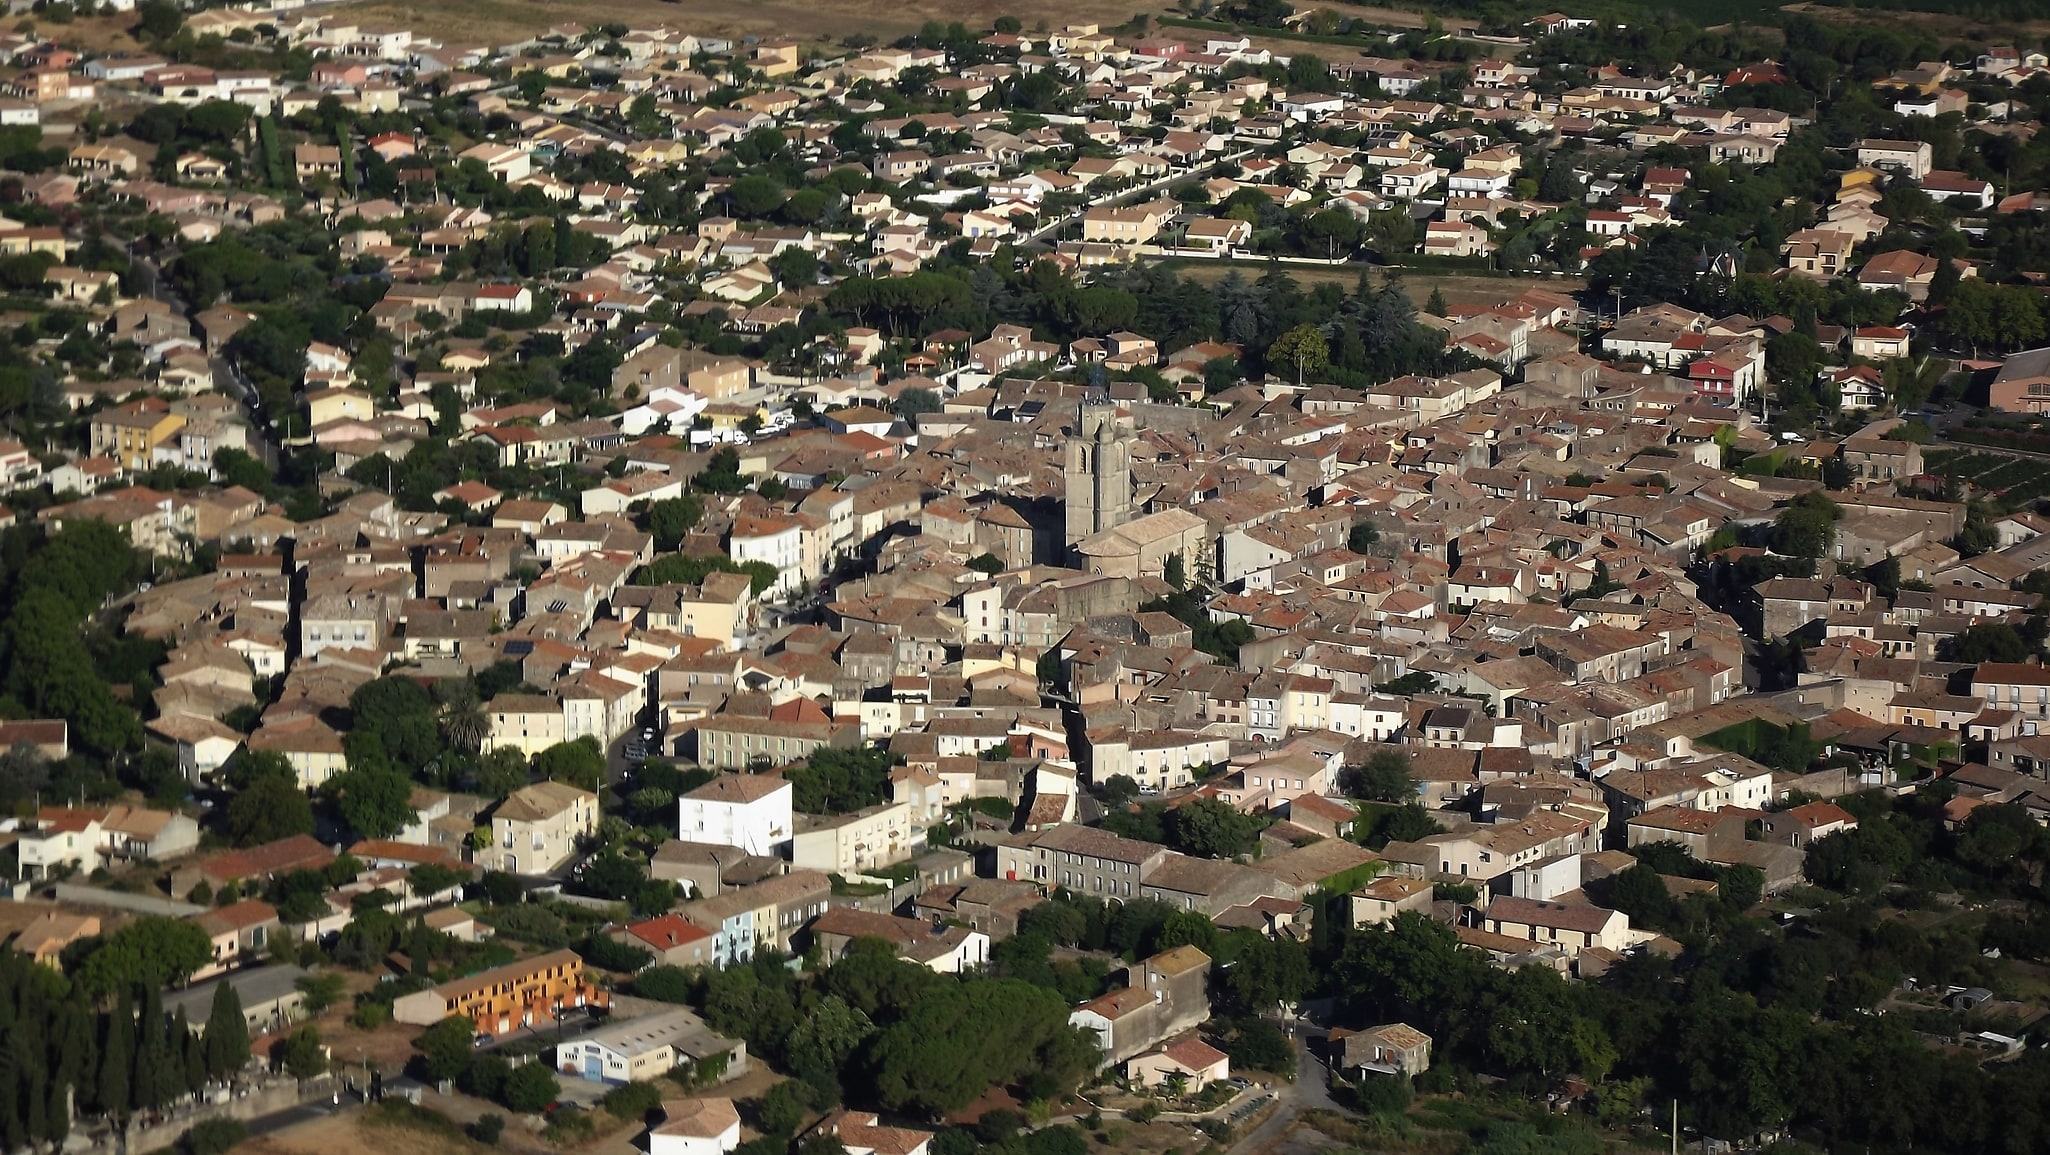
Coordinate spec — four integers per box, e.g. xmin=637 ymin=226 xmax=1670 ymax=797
xmin=342 ymin=0 xmax=1164 ymax=41
